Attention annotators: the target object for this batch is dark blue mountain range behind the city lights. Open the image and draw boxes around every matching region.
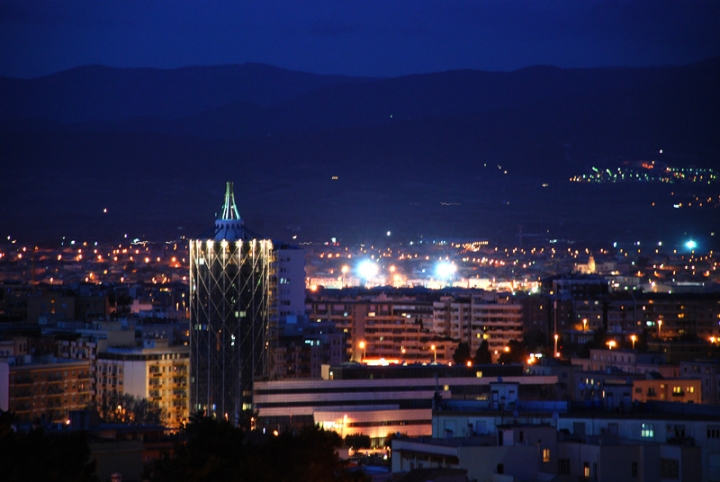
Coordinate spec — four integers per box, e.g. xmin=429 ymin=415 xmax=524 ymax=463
xmin=0 ymin=57 xmax=720 ymax=249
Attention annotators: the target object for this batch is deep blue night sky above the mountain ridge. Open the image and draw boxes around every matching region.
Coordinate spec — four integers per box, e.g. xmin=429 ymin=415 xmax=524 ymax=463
xmin=0 ymin=0 xmax=720 ymax=77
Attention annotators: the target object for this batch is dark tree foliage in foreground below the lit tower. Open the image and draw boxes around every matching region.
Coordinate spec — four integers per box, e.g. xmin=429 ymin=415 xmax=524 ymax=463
xmin=147 ymin=416 xmax=369 ymax=482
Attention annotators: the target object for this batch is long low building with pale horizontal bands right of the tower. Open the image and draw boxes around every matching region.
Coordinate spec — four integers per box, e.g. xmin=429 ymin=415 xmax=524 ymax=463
xmin=254 ymin=365 xmax=557 ymax=446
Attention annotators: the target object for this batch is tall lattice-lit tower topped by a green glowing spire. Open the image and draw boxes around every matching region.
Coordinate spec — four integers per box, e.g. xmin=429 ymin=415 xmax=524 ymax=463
xmin=190 ymin=182 xmax=273 ymax=424
